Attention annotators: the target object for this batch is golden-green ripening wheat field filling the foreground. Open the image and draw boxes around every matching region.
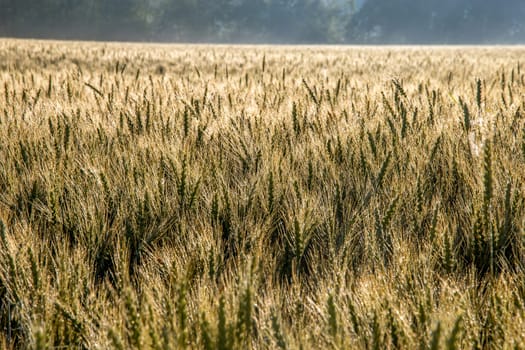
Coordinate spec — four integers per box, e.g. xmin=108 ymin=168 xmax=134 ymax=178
xmin=0 ymin=39 xmax=525 ymax=349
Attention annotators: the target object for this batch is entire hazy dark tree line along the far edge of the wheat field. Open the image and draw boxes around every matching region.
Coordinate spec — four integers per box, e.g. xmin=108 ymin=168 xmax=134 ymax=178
xmin=0 ymin=0 xmax=525 ymax=44
